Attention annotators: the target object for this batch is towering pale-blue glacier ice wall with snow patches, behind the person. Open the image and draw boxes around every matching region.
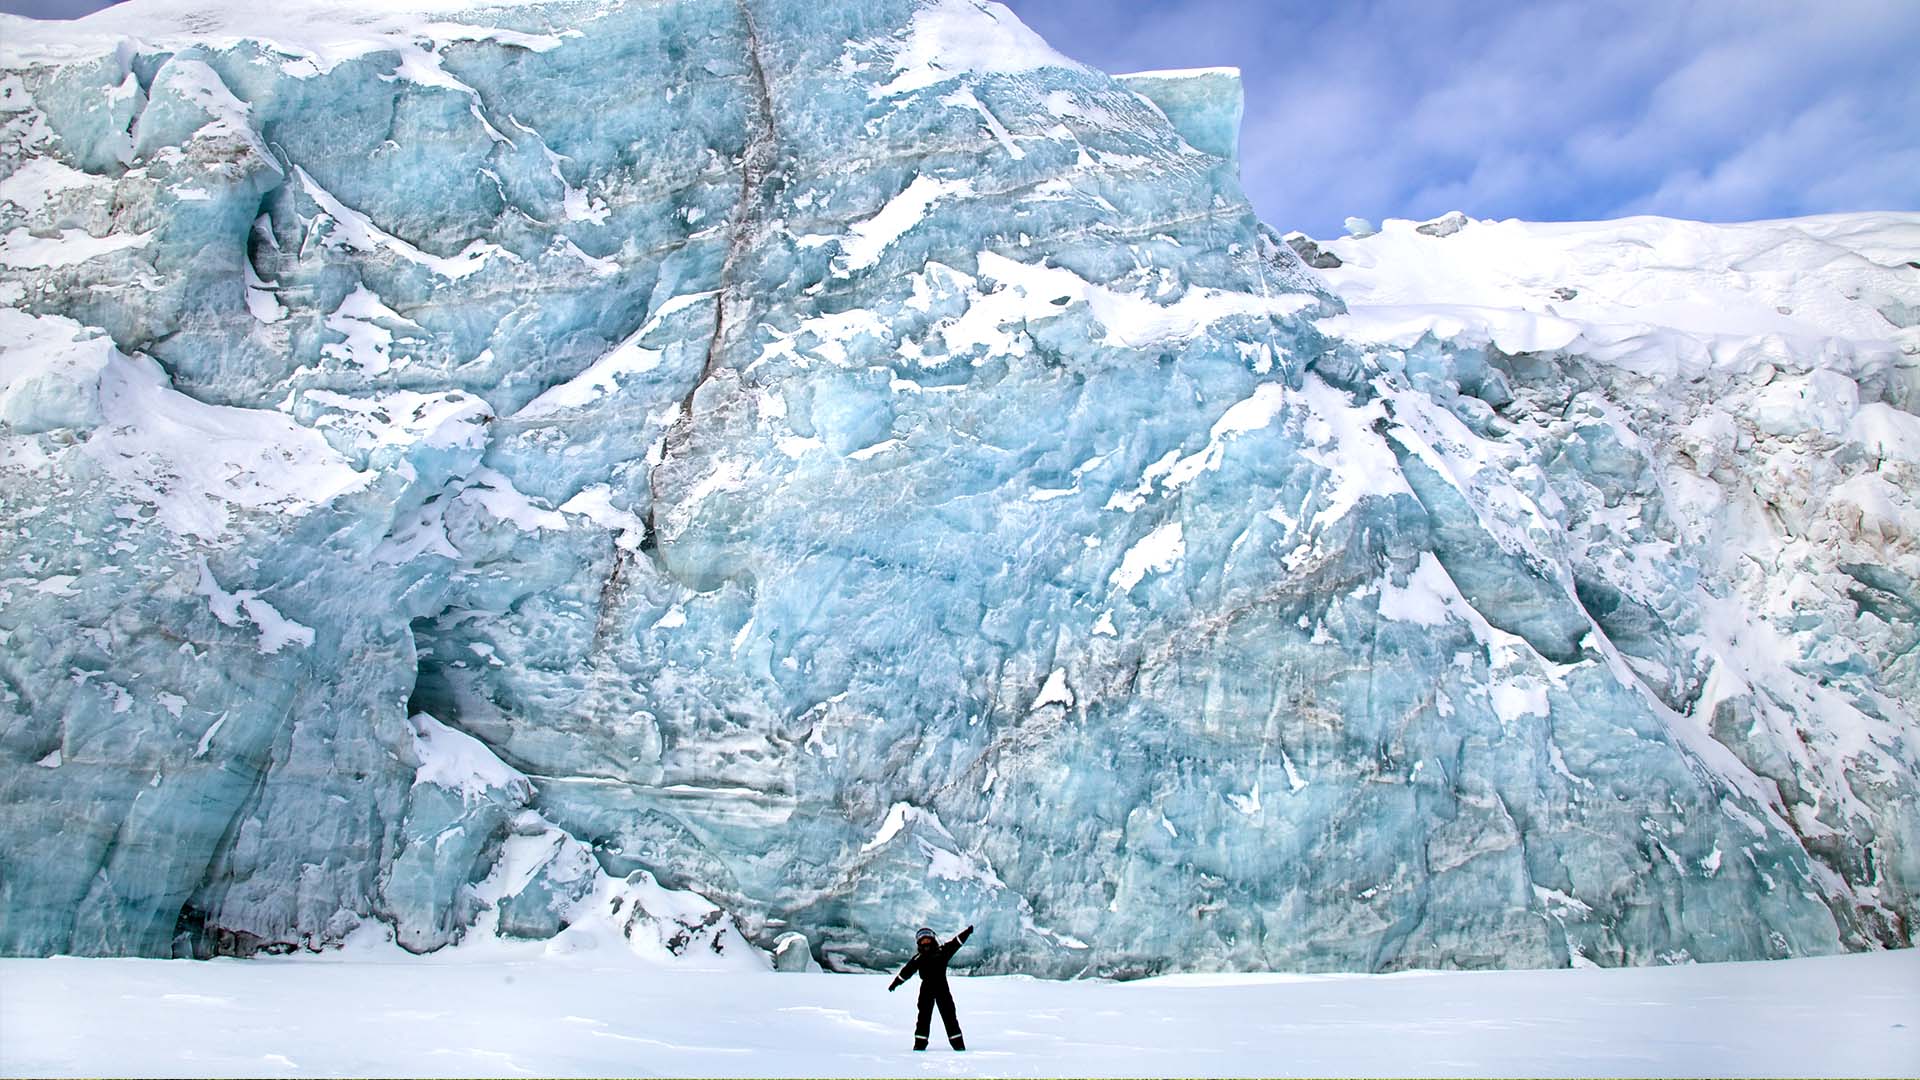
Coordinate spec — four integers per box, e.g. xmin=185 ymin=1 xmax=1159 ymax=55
xmin=0 ymin=0 xmax=1920 ymax=976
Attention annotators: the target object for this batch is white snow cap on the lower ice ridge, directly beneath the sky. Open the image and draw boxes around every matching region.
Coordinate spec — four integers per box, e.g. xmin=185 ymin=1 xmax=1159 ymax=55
xmin=1319 ymin=211 xmax=1920 ymax=379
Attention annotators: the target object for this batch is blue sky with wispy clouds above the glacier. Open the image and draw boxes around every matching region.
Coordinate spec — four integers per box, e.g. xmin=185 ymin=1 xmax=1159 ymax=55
xmin=0 ymin=0 xmax=1920 ymax=236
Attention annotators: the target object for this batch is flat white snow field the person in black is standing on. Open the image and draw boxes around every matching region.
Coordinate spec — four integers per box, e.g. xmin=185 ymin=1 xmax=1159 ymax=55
xmin=0 ymin=951 xmax=1920 ymax=1076
